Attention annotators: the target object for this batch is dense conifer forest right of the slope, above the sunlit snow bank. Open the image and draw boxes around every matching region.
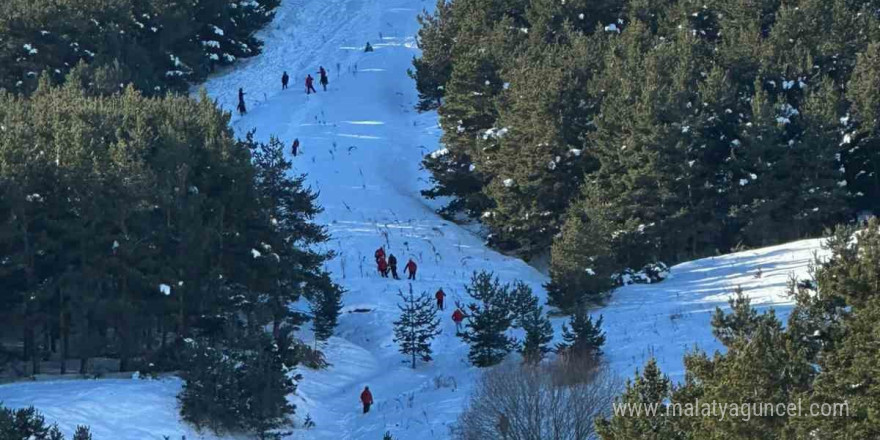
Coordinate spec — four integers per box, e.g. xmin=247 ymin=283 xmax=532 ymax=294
xmin=411 ymin=0 xmax=880 ymax=309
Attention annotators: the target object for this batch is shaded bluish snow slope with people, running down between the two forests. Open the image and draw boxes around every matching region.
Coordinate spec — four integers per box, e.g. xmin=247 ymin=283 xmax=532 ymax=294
xmin=206 ymin=0 xmax=544 ymax=439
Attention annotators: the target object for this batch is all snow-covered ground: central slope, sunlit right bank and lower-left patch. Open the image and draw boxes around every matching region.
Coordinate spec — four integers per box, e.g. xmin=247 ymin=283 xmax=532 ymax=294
xmin=0 ymin=0 xmax=819 ymax=440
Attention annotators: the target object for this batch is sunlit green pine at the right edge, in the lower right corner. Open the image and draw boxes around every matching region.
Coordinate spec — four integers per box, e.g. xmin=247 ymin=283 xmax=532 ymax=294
xmin=795 ymin=220 xmax=880 ymax=438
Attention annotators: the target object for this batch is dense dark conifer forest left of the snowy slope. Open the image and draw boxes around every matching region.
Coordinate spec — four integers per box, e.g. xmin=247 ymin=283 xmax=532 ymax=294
xmin=0 ymin=0 xmax=342 ymax=438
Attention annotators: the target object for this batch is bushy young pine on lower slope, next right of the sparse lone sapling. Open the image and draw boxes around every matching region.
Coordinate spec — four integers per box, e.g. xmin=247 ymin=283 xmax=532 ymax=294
xmin=461 ymin=271 xmax=516 ymax=367
